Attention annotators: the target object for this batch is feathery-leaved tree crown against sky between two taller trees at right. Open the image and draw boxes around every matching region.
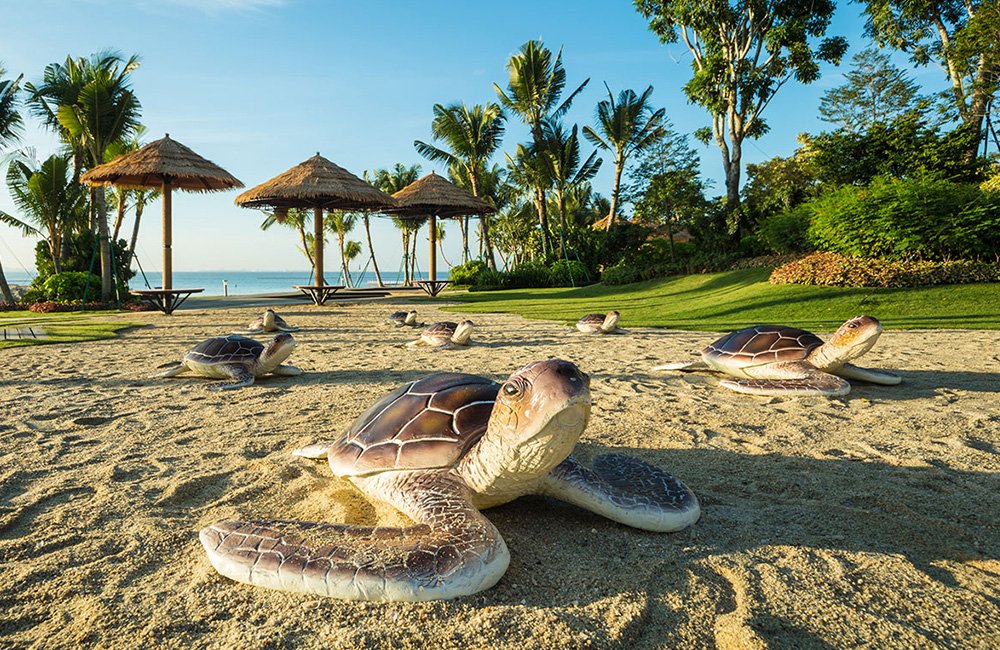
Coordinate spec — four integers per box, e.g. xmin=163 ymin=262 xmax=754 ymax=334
xmin=819 ymin=48 xmax=922 ymax=133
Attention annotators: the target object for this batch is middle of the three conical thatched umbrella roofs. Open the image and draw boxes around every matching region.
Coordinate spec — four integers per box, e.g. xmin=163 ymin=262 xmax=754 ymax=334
xmin=236 ymin=153 xmax=396 ymax=210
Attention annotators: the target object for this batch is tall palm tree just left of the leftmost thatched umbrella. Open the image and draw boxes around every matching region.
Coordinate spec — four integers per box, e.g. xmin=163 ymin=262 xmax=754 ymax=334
xmin=26 ymin=52 xmax=141 ymax=301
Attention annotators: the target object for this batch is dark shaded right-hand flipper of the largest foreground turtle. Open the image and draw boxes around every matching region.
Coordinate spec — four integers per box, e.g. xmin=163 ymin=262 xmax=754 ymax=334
xmin=542 ymin=454 xmax=701 ymax=533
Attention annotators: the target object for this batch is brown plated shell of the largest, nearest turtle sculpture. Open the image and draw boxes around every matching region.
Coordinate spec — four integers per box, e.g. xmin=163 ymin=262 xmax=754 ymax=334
xmin=328 ymin=372 xmax=500 ymax=476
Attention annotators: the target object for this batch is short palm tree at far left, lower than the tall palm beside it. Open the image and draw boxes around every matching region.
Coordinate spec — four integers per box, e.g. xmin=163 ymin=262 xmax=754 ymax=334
xmin=0 ymin=154 xmax=87 ymax=273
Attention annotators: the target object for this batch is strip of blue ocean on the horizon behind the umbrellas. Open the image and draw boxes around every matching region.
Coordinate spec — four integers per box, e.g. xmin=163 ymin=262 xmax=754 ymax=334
xmin=4 ymin=269 xmax=430 ymax=296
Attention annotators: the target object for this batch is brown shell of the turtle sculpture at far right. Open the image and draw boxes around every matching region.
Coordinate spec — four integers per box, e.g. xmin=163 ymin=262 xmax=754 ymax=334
xmin=702 ymin=325 xmax=823 ymax=367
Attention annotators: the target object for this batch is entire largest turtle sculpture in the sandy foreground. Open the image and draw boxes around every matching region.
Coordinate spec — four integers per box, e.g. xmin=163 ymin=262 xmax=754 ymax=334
xmin=200 ymin=359 xmax=700 ymax=601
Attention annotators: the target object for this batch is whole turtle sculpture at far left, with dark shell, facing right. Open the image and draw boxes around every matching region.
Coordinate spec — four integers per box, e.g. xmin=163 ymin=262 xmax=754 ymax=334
xmin=157 ymin=332 xmax=302 ymax=390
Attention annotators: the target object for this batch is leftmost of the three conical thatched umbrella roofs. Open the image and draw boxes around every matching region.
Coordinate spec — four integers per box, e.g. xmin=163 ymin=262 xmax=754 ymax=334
xmin=80 ymin=134 xmax=243 ymax=192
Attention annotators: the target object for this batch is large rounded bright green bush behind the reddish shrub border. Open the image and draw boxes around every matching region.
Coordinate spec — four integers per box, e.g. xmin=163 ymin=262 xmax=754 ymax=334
xmin=809 ymin=178 xmax=1000 ymax=260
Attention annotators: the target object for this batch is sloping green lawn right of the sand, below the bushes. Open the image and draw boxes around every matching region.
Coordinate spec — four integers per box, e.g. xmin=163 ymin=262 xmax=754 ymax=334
xmin=443 ymin=269 xmax=1000 ymax=332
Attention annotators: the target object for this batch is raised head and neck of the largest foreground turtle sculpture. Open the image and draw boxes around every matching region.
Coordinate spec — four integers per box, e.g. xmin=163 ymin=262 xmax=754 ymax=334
xmin=458 ymin=359 xmax=590 ymax=498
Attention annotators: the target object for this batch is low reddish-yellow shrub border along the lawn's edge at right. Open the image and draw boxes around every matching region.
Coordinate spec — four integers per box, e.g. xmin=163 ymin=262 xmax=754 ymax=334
xmin=770 ymin=253 xmax=1000 ymax=287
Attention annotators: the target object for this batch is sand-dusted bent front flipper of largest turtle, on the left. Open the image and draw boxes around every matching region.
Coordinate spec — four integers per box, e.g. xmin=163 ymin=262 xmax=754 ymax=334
xmin=199 ymin=472 xmax=510 ymax=601
